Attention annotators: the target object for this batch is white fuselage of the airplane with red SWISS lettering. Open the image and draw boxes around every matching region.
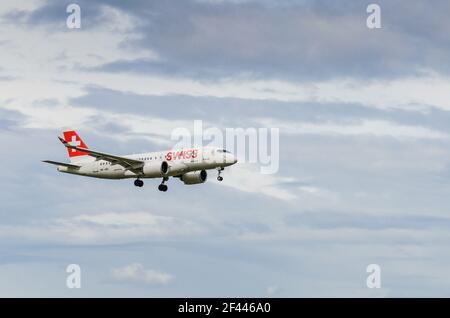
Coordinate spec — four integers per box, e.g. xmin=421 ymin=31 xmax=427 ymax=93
xmin=58 ymin=148 xmax=237 ymax=179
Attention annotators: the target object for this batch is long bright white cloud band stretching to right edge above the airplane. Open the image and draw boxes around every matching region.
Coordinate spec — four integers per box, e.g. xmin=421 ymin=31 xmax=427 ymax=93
xmin=44 ymin=72 xmax=450 ymax=112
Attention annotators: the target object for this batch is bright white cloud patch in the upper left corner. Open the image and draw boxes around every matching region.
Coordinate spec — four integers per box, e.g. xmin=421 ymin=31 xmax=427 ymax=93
xmin=0 ymin=5 xmax=158 ymax=73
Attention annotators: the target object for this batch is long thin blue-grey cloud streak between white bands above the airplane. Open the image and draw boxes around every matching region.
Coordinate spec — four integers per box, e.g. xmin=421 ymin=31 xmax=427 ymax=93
xmin=71 ymin=87 xmax=450 ymax=134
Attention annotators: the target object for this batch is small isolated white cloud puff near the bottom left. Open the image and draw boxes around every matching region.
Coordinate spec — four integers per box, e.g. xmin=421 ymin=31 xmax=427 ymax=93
xmin=111 ymin=263 xmax=175 ymax=285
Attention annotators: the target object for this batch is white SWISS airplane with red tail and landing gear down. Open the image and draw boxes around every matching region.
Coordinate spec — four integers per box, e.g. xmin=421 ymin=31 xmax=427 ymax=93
xmin=43 ymin=130 xmax=237 ymax=192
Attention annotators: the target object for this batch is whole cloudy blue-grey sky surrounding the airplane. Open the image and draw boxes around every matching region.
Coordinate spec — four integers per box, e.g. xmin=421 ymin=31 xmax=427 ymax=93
xmin=0 ymin=0 xmax=450 ymax=297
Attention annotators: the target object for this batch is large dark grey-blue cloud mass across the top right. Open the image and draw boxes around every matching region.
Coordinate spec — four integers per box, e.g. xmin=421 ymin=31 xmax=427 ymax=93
xmin=9 ymin=0 xmax=450 ymax=80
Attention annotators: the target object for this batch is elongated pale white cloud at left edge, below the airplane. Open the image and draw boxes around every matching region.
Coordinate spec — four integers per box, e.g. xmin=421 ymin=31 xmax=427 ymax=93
xmin=0 ymin=212 xmax=205 ymax=245
